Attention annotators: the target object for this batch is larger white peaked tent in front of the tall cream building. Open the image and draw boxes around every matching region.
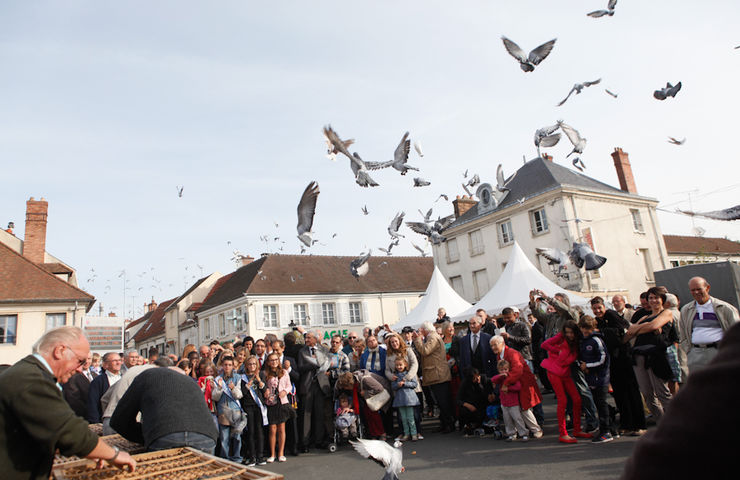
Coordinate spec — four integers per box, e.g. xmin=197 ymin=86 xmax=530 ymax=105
xmin=450 ymin=242 xmax=590 ymax=322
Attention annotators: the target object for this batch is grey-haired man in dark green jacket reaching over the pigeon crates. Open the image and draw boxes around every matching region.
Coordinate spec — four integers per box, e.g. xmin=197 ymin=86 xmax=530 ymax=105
xmin=0 ymin=326 xmax=136 ymax=480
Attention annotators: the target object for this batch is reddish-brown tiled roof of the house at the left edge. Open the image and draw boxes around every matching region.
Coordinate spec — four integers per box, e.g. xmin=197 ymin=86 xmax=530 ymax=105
xmin=0 ymin=243 xmax=95 ymax=311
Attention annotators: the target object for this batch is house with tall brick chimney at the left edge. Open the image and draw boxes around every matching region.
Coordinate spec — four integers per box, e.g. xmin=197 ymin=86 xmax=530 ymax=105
xmin=0 ymin=197 xmax=95 ymax=364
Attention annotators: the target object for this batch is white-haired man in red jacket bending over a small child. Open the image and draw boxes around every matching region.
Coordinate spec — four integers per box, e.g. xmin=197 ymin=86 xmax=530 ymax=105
xmin=491 ymin=335 xmax=542 ymax=438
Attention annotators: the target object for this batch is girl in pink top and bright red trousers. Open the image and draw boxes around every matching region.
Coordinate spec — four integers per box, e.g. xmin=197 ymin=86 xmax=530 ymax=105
xmin=541 ymin=320 xmax=591 ymax=443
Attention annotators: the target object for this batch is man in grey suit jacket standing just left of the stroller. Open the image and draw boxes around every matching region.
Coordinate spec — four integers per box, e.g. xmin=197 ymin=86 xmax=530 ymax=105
xmin=298 ymin=330 xmax=329 ymax=453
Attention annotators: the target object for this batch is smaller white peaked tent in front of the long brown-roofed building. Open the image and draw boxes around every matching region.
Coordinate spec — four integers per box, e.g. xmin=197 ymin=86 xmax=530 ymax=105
xmin=392 ymin=265 xmax=470 ymax=332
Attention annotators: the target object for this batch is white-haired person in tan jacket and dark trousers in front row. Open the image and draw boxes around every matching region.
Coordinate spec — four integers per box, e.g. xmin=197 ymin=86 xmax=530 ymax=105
xmin=413 ymin=322 xmax=455 ymax=433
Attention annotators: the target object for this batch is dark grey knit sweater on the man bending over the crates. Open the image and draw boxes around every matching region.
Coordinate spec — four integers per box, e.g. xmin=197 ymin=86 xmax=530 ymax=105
xmin=110 ymin=368 xmax=218 ymax=447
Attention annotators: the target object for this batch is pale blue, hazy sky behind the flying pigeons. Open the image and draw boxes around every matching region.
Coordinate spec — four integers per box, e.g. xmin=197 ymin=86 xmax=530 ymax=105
xmin=0 ymin=0 xmax=740 ymax=317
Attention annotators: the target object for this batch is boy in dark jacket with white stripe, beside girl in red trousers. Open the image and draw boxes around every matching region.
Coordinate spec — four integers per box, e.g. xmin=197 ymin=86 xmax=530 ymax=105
xmin=578 ymin=315 xmax=614 ymax=443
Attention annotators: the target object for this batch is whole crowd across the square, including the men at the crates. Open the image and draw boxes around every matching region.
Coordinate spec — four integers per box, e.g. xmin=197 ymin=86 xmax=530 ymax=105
xmin=0 ymin=277 xmax=739 ymax=478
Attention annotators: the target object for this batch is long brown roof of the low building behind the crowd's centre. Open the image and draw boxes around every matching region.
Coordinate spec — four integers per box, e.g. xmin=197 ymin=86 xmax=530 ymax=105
xmin=198 ymin=254 xmax=434 ymax=311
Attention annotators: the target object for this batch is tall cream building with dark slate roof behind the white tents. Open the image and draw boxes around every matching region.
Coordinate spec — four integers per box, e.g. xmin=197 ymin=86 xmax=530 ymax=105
xmin=433 ymin=148 xmax=668 ymax=303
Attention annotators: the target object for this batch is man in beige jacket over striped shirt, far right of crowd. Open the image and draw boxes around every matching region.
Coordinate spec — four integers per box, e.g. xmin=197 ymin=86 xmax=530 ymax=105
xmin=679 ymin=277 xmax=740 ymax=374
